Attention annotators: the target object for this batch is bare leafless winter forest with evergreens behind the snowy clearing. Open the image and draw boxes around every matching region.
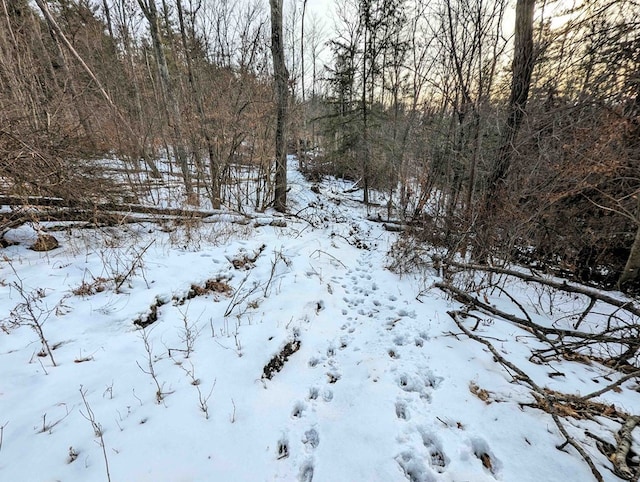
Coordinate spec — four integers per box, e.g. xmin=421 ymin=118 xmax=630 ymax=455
xmin=0 ymin=0 xmax=640 ymax=293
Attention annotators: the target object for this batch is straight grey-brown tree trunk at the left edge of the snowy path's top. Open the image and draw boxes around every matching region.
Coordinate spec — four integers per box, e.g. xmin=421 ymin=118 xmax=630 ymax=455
xmin=269 ymin=0 xmax=289 ymax=212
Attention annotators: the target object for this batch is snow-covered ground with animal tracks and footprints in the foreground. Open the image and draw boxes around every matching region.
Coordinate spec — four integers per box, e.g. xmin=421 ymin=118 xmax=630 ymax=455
xmin=0 ymin=163 xmax=640 ymax=482
